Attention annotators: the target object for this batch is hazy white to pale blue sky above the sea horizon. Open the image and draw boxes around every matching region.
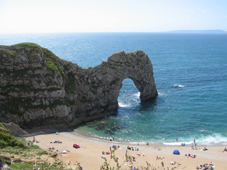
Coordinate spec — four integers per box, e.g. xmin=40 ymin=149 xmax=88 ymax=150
xmin=0 ymin=0 xmax=227 ymax=33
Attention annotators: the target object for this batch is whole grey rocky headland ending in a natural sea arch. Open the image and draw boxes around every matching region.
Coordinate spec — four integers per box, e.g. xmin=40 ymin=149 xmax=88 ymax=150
xmin=0 ymin=43 xmax=158 ymax=127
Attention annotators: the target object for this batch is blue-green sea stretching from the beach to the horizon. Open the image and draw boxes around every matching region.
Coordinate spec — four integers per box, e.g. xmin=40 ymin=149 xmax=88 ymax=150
xmin=0 ymin=33 xmax=227 ymax=145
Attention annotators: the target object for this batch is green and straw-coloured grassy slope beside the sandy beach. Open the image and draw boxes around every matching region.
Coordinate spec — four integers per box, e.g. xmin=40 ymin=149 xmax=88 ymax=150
xmin=0 ymin=122 xmax=65 ymax=170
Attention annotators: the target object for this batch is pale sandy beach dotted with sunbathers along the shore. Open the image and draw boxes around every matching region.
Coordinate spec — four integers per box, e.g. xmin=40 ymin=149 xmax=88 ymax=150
xmin=26 ymin=129 xmax=227 ymax=170
